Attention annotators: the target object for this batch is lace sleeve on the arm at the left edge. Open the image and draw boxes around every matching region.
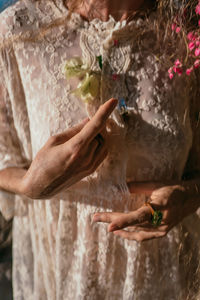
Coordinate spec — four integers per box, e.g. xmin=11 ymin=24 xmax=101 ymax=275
xmin=0 ymin=49 xmax=31 ymax=220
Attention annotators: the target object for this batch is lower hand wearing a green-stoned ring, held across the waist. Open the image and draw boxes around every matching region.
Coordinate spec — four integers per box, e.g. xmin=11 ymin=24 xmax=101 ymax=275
xmin=93 ymin=183 xmax=198 ymax=242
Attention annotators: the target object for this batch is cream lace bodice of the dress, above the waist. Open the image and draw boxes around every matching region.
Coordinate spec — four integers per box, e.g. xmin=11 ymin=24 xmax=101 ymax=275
xmin=1 ymin=1 xmax=192 ymax=181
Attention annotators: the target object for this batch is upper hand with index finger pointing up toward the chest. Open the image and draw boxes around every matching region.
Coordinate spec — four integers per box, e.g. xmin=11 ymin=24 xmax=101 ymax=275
xmin=22 ymin=99 xmax=117 ymax=199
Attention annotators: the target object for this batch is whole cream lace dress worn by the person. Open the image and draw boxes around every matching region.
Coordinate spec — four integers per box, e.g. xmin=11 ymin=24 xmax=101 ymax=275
xmin=0 ymin=0 xmax=200 ymax=300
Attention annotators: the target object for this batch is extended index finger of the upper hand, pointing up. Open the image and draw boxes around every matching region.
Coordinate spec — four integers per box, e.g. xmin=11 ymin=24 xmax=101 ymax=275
xmin=77 ymin=98 xmax=118 ymax=142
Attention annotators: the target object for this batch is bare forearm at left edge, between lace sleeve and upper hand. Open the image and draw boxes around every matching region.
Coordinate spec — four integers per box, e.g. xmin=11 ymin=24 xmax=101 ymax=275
xmin=0 ymin=167 xmax=27 ymax=194
